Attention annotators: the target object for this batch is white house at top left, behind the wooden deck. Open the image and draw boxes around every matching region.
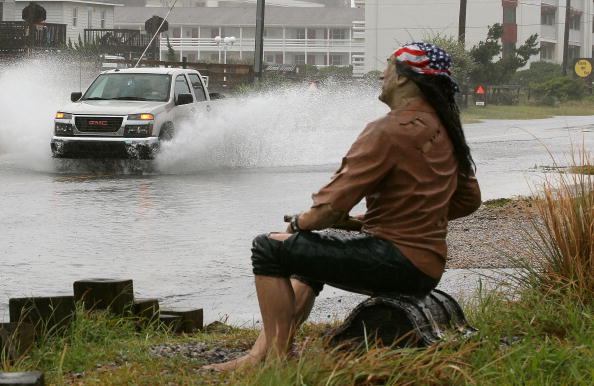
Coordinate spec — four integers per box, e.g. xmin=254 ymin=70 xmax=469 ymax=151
xmin=0 ymin=0 xmax=121 ymax=43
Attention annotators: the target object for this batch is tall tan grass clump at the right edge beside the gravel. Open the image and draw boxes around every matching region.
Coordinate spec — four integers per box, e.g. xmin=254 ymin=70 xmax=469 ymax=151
xmin=518 ymin=150 xmax=594 ymax=303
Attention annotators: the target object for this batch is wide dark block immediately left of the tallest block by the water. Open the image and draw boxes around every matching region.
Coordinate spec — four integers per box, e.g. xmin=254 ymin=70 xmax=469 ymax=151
xmin=8 ymin=296 xmax=75 ymax=334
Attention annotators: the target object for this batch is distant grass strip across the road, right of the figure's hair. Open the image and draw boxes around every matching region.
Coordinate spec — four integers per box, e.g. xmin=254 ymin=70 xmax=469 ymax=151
xmin=461 ymin=99 xmax=594 ymax=124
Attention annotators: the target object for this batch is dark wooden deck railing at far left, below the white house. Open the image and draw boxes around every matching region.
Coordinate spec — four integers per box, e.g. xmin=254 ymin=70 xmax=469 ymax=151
xmin=0 ymin=21 xmax=66 ymax=53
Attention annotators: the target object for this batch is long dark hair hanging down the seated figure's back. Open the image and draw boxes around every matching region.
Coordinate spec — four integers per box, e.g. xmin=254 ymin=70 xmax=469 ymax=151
xmin=396 ymin=62 xmax=476 ymax=175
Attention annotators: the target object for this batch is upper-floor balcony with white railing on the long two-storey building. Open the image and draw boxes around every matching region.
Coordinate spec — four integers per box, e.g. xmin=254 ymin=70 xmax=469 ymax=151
xmin=160 ymin=38 xmax=365 ymax=52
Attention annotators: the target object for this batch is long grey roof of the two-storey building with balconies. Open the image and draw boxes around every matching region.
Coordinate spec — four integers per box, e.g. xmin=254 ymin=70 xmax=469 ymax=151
xmin=114 ymin=7 xmax=365 ymax=27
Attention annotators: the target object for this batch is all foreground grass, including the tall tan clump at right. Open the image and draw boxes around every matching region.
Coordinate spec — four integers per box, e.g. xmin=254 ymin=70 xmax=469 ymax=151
xmin=2 ymin=153 xmax=594 ymax=386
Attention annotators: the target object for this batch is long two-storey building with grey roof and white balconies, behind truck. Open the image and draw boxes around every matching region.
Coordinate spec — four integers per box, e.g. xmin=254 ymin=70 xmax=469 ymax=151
xmin=115 ymin=6 xmax=364 ymax=74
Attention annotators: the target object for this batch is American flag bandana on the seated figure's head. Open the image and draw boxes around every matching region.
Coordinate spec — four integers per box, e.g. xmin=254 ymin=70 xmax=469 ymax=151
xmin=394 ymin=43 xmax=459 ymax=92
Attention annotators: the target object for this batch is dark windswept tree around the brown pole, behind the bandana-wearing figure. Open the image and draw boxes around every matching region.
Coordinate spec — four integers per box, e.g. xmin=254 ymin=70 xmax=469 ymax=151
xmin=470 ymin=23 xmax=540 ymax=85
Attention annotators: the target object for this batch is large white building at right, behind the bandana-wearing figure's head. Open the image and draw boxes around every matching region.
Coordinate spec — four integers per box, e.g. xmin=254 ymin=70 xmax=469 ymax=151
xmin=365 ymin=0 xmax=594 ymax=71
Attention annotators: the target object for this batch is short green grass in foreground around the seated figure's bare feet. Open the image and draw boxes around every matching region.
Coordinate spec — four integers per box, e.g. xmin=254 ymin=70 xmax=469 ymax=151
xmin=4 ymin=284 xmax=594 ymax=385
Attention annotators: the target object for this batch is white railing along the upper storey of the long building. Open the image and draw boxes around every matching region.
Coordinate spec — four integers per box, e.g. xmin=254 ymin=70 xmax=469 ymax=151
xmin=161 ymin=38 xmax=365 ymax=50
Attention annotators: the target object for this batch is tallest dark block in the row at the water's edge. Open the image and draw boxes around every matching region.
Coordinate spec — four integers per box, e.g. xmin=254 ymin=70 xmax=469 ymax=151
xmin=74 ymin=279 xmax=134 ymax=315
